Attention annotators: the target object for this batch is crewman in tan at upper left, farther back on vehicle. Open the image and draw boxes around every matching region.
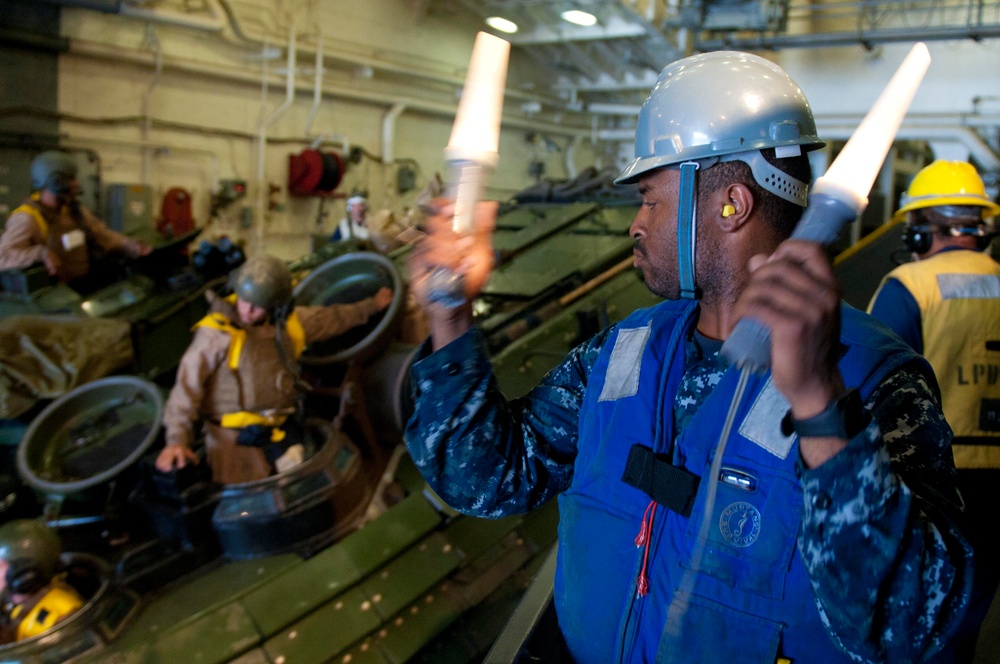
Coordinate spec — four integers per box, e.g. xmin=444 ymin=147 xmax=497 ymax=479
xmin=0 ymin=150 xmax=152 ymax=290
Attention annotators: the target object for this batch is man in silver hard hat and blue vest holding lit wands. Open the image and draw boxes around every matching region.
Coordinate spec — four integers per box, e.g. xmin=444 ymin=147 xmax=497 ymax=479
xmin=406 ymin=52 xmax=971 ymax=664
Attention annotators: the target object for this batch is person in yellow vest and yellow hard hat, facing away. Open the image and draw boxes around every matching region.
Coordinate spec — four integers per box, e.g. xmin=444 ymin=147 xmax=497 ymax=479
xmin=868 ymin=160 xmax=1000 ymax=661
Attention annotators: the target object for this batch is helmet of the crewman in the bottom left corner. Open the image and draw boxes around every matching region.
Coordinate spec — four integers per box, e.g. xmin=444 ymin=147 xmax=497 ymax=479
xmin=0 ymin=519 xmax=61 ymax=594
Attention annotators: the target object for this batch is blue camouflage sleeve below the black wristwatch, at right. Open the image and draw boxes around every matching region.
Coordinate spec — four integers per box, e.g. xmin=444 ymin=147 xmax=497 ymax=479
xmin=799 ymin=368 xmax=972 ymax=662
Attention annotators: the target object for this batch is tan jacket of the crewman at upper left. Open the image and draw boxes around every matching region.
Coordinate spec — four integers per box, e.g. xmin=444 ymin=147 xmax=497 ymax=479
xmin=0 ymin=194 xmax=138 ymax=281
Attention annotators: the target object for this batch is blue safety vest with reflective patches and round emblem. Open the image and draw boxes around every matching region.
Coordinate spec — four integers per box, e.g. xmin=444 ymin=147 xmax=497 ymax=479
xmin=555 ymin=301 xmax=917 ymax=664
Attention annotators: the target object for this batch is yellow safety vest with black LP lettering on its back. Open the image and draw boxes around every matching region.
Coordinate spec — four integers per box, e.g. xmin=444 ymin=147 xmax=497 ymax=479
xmin=886 ymin=250 xmax=1000 ymax=468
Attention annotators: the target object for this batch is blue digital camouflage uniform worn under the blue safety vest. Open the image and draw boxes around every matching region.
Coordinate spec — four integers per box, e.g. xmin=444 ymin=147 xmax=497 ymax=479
xmin=406 ymin=304 xmax=971 ymax=662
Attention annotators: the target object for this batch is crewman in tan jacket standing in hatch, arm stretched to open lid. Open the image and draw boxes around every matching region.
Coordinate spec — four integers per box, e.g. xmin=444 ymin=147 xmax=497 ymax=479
xmin=156 ymin=256 xmax=393 ymax=484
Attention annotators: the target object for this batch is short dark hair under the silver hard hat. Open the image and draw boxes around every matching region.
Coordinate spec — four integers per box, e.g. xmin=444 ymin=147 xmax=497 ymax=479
xmin=698 ymin=148 xmax=812 ymax=238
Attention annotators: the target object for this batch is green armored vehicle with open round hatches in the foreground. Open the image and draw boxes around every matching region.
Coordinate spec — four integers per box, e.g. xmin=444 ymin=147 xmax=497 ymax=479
xmin=0 ymin=198 xmax=656 ymax=664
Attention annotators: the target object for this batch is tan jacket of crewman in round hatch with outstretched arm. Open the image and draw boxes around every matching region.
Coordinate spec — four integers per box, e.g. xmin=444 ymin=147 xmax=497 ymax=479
xmin=163 ymin=298 xmax=376 ymax=483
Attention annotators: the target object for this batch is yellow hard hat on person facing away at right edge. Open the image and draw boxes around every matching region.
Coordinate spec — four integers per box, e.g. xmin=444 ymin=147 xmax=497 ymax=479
xmin=893 ymin=159 xmax=1000 ymax=219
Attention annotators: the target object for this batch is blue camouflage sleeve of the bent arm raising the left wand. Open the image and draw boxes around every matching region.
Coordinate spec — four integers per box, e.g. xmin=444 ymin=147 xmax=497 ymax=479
xmin=406 ymin=328 xmax=609 ymax=518
